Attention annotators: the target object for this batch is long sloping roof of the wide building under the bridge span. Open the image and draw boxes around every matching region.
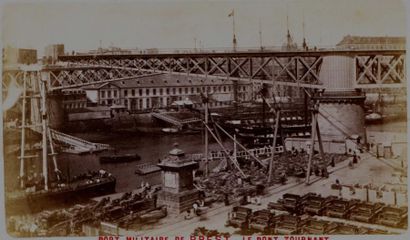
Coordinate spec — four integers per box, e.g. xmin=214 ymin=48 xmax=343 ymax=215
xmin=83 ymin=74 xmax=249 ymax=90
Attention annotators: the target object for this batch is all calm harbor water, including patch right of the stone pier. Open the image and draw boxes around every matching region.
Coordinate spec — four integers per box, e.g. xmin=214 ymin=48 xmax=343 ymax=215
xmin=4 ymin=121 xmax=407 ymax=192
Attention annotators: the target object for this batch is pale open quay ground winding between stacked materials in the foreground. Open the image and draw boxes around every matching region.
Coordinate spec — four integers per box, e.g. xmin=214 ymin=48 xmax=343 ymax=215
xmin=121 ymin=153 xmax=407 ymax=236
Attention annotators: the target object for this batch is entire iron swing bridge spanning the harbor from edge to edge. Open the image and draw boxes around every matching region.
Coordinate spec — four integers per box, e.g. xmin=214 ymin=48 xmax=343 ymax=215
xmin=2 ymin=49 xmax=406 ymax=186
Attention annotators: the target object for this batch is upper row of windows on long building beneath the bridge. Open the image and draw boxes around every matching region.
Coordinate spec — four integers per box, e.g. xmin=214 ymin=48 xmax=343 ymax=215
xmin=100 ymin=86 xmax=246 ymax=98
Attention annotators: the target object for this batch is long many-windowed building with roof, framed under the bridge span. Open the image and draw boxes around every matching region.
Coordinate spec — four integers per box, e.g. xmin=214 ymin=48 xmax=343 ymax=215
xmin=85 ymin=74 xmax=252 ymax=111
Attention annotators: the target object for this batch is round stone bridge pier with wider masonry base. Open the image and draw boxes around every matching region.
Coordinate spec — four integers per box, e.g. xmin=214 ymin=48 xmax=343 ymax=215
xmin=313 ymin=56 xmax=366 ymax=143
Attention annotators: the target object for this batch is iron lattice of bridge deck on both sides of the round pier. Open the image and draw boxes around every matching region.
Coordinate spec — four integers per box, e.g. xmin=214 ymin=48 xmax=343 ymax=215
xmin=59 ymin=50 xmax=405 ymax=88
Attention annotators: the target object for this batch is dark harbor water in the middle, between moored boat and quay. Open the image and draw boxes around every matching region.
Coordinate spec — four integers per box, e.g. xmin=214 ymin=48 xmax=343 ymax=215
xmin=58 ymin=132 xmax=232 ymax=192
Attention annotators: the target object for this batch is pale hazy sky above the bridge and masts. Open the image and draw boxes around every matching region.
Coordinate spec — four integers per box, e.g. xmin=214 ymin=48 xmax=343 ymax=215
xmin=0 ymin=0 xmax=406 ymax=56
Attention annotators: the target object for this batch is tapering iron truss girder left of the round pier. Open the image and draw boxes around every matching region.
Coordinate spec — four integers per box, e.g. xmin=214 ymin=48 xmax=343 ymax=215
xmin=60 ymin=56 xmax=323 ymax=88
